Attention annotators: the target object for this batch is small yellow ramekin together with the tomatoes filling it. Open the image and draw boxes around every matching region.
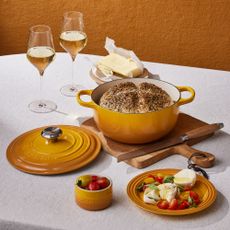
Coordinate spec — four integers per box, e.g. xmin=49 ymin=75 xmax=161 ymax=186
xmin=75 ymin=174 xmax=112 ymax=211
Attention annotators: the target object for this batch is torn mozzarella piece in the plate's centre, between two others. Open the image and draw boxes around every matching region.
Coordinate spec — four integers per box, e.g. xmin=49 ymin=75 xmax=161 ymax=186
xmin=157 ymin=183 xmax=177 ymax=202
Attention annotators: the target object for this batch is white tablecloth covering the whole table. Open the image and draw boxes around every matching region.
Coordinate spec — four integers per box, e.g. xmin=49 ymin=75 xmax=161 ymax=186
xmin=0 ymin=53 xmax=230 ymax=230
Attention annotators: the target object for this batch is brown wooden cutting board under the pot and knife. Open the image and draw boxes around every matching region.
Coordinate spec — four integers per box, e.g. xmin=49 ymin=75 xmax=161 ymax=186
xmin=81 ymin=113 xmax=215 ymax=168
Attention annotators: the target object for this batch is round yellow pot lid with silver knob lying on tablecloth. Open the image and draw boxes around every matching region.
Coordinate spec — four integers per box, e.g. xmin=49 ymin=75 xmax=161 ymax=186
xmin=7 ymin=125 xmax=101 ymax=175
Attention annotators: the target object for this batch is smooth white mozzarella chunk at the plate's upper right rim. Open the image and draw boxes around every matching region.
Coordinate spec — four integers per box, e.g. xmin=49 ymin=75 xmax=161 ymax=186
xmin=174 ymin=169 xmax=196 ymax=187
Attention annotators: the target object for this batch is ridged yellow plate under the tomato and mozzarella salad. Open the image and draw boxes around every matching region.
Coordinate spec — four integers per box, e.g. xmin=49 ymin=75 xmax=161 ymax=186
xmin=127 ymin=169 xmax=217 ymax=216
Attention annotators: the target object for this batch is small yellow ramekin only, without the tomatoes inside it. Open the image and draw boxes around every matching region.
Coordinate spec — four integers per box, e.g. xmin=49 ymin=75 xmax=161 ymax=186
xmin=75 ymin=177 xmax=112 ymax=211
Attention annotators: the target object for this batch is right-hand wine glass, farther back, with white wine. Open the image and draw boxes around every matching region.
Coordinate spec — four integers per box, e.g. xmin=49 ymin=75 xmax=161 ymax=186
xmin=59 ymin=11 xmax=87 ymax=97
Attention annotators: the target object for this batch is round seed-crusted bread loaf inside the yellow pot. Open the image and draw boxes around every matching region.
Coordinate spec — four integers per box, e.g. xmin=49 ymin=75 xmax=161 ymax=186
xmin=99 ymin=82 xmax=172 ymax=113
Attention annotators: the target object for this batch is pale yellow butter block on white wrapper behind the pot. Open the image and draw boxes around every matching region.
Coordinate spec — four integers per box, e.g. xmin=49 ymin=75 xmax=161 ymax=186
xmin=97 ymin=53 xmax=142 ymax=77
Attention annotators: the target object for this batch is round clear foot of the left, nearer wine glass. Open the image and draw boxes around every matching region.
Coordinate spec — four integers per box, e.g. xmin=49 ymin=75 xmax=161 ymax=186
xmin=28 ymin=100 xmax=57 ymax=113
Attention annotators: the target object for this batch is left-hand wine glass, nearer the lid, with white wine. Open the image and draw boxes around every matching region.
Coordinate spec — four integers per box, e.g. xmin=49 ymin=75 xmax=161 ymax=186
xmin=27 ymin=25 xmax=57 ymax=113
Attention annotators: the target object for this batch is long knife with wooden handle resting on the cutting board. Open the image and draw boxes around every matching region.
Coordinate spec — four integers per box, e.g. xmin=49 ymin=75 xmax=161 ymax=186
xmin=117 ymin=123 xmax=224 ymax=162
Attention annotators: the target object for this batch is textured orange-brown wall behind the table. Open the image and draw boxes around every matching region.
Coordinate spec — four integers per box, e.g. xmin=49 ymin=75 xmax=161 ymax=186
xmin=0 ymin=0 xmax=230 ymax=70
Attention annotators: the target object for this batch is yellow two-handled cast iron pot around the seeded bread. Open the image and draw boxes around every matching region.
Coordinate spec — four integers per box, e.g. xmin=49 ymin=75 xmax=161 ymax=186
xmin=76 ymin=78 xmax=195 ymax=144
